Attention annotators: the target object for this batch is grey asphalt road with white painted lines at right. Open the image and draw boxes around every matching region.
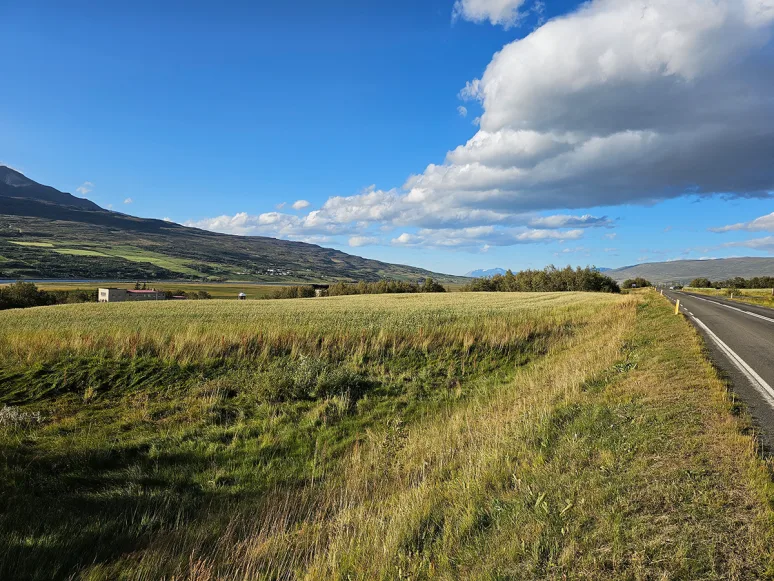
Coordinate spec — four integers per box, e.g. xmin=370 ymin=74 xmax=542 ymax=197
xmin=664 ymin=291 xmax=774 ymax=453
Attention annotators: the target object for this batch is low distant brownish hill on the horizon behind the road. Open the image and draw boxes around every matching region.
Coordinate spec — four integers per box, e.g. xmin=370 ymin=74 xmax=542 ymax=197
xmin=606 ymin=258 xmax=774 ymax=284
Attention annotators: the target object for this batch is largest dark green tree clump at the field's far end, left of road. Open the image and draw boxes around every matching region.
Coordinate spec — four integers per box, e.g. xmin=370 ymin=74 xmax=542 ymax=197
xmin=462 ymin=265 xmax=621 ymax=293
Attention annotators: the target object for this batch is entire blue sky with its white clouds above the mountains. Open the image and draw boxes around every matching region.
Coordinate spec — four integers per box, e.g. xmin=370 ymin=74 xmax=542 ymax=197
xmin=0 ymin=0 xmax=774 ymax=274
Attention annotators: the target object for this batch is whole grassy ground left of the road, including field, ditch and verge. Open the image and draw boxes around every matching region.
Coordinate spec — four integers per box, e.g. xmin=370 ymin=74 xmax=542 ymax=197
xmin=0 ymin=293 xmax=774 ymax=581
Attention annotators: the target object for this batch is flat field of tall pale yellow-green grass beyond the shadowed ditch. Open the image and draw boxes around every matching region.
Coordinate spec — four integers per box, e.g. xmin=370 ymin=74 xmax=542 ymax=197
xmin=0 ymin=293 xmax=622 ymax=365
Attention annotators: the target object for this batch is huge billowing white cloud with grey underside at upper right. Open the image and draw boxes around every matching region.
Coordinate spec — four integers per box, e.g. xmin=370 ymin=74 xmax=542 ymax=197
xmin=188 ymin=0 xmax=774 ymax=246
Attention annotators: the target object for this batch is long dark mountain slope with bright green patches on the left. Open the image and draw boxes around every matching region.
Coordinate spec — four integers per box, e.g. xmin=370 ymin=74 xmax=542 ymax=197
xmin=0 ymin=166 xmax=467 ymax=284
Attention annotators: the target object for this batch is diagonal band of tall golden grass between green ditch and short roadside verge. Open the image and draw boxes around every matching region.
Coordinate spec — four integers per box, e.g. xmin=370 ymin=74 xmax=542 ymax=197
xmin=107 ymin=295 xmax=637 ymax=581
